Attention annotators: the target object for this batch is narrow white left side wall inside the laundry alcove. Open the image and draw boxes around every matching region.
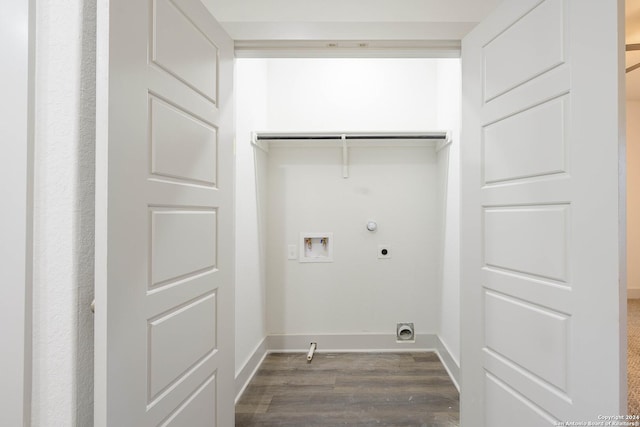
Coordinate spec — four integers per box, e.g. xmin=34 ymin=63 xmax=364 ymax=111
xmin=235 ymin=59 xmax=267 ymax=374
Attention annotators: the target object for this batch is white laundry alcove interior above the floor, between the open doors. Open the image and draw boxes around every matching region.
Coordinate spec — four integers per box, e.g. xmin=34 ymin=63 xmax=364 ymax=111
xmin=236 ymin=59 xmax=460 ymax=404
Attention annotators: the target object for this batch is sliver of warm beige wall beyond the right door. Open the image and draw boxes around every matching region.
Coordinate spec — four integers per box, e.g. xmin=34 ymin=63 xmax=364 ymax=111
xmin=627 ymin=100 xmax=640 ymax=298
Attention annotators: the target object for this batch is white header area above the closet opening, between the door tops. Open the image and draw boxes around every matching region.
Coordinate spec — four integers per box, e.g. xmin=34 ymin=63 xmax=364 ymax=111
xmin=203 ymin=0 xmax=501 ymax=40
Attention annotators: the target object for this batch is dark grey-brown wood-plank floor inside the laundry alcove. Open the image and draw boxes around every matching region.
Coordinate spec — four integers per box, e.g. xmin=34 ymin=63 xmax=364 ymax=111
xmin=236 ymin=353 xmax=459 ymax=427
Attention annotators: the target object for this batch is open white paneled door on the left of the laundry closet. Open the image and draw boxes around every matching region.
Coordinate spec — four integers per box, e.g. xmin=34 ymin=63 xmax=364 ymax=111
xmin=95 ymin=0 xmax=235 ymax=427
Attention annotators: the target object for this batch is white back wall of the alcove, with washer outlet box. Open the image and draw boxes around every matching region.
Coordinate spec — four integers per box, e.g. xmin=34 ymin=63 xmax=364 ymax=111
xmin=258 ymin=59 xmax=440 ymax=335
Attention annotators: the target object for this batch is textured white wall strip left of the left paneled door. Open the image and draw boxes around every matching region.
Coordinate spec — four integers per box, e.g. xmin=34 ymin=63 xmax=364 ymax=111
xmin=32 ymin=0 xmax=95 ymax=427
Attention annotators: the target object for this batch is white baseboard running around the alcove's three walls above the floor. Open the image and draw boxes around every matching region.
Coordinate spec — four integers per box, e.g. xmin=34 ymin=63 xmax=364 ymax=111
xmin=235 ymin=334 xmax=460 ymax=402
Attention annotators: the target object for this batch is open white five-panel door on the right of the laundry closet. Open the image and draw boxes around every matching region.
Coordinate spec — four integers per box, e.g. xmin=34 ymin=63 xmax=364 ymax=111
xmin=461 ymin=0 xmax=626 ymax=427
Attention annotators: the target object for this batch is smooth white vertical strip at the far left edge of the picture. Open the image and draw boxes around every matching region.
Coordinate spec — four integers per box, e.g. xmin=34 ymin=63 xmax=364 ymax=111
xmin=0 ymin=0 xmax=36 ymax=426
